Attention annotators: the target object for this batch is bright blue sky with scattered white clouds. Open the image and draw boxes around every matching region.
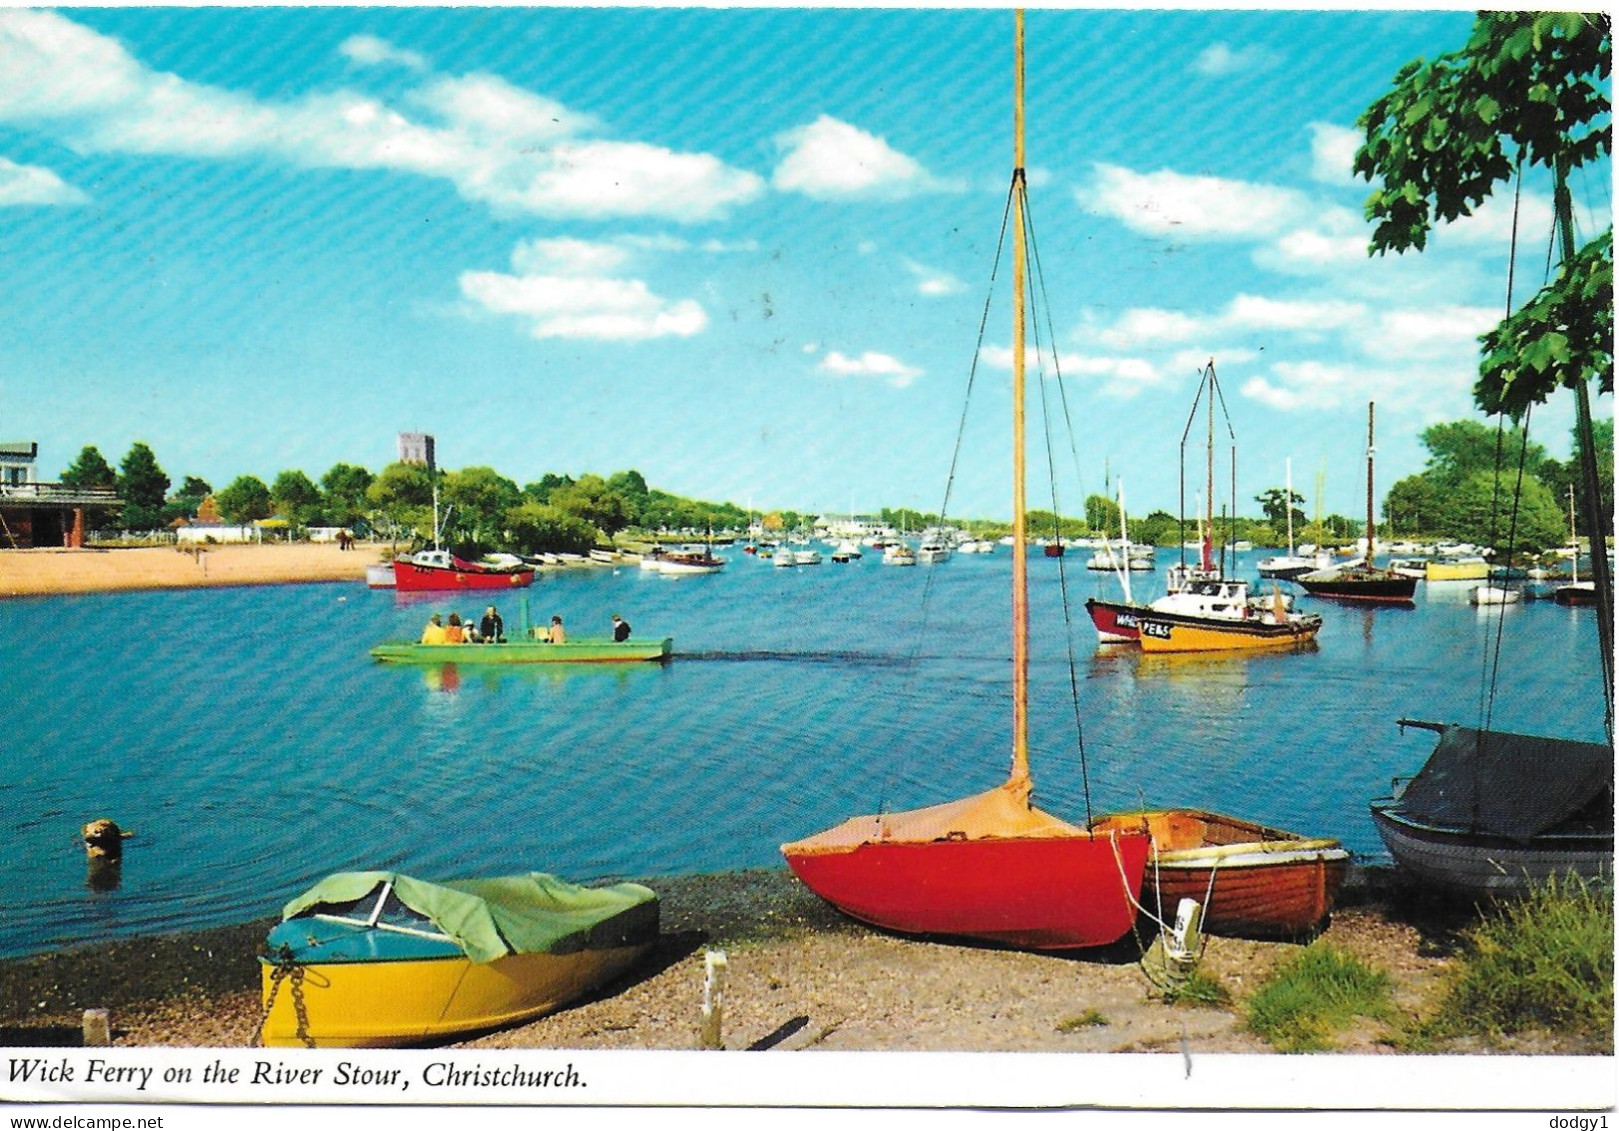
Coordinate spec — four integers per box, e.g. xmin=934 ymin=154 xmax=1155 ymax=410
xmin=0 ymin=8 xmax=1611 ymax=518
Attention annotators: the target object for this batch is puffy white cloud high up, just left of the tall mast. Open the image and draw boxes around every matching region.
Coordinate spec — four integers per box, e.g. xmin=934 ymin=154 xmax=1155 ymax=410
xmin=772 ymin=115 xmax=942 ymax=201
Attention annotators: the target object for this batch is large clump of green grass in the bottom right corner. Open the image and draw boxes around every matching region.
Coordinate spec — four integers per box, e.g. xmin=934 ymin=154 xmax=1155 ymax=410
xmin=1430 ymin=877 xmax=1614 ymax=1052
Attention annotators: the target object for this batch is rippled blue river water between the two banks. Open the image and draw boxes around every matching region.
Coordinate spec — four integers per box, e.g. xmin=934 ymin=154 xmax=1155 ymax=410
xmin=0 ymin=549 xmax=1604 ymax=955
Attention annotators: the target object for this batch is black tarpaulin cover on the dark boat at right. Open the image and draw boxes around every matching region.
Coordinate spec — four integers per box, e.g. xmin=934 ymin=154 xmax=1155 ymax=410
xmin=1400 ymin=720 xmax=1614 ymax=840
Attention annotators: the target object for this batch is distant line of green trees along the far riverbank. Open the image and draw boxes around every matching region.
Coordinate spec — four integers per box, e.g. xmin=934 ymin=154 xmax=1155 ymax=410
xmin=60 ymin=421 xmax=1613 ymax=553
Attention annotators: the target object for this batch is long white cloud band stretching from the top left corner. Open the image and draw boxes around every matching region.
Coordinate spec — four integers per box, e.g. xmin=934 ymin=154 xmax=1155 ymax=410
xmin=0 ymin=10 xmax=764 ymax=220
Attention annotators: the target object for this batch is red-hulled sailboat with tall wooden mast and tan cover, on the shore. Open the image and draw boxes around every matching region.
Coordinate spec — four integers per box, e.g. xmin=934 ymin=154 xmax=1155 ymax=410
xmin=782 ymin=11 xmax=1151 ymax=950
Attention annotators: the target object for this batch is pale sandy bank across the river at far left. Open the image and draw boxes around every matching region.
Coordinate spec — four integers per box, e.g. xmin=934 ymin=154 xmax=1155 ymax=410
xmin=0 ymin=542 xmax=382 ymax=597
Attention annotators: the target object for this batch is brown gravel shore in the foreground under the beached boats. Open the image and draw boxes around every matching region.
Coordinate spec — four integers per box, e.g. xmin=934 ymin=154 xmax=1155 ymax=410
xmin=0 ymin=870 xmax=1593 ymax=1053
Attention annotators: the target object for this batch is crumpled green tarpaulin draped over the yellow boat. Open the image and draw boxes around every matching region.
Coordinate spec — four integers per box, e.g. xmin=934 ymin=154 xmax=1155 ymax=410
xmin=282 ymin=872 xmax=657 ymax=963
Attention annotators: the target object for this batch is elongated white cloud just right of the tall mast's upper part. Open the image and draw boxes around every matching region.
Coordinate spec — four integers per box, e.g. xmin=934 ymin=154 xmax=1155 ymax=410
xmin=1077 ymin=163 xmax=1313 ymax=239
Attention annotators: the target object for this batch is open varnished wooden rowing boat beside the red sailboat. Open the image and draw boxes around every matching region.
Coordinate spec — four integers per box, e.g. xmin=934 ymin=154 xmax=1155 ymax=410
xmin=1091 ymin=809 xmax=1349 ymax=937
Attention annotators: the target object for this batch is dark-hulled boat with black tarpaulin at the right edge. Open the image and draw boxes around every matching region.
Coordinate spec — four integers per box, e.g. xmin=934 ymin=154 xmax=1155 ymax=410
xmin=1371 ymin=718 xmax=1614 ymax=900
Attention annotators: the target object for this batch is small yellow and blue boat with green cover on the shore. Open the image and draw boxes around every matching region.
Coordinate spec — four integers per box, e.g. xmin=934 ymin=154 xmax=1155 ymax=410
xmin=259 ymin=872 xmax=659 ymax=1048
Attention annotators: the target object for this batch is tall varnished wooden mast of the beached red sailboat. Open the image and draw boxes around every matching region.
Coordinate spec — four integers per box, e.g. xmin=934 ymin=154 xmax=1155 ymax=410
xmin=1012 ymin=8 xmax=1028 ymax=782
